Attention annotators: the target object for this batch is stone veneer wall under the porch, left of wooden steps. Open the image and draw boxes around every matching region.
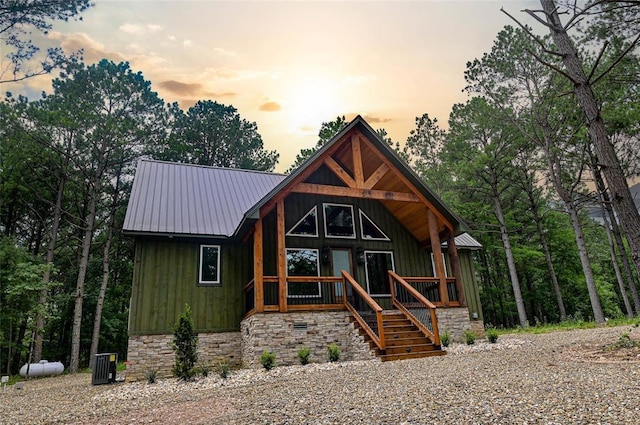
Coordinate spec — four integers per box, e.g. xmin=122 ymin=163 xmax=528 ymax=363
xmin=240 ymin=311 xmax=376 ymax=367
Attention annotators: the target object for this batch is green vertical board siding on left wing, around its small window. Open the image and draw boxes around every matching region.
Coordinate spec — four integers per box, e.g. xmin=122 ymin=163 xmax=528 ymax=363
xmin=129 ymin=238 xmax=253 ymax=335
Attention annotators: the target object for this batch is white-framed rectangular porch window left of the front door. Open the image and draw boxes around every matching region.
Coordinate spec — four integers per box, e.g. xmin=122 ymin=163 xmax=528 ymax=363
xmin=287 ymin=248 xmax=320 ymax=298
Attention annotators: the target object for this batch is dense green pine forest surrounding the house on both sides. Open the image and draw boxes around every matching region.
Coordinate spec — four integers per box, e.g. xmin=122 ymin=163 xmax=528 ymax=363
xmin=0 ymin=0 xmax=640 ymax=373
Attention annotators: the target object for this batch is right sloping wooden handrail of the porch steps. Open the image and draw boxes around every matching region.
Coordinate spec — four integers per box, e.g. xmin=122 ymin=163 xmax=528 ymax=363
xmin=389 ymin=270 xmax=440 ymax=346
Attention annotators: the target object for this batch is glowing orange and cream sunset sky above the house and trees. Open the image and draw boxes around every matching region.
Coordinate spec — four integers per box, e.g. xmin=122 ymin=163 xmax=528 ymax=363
xmin=11 ymin=0 xmax=538 ymax=171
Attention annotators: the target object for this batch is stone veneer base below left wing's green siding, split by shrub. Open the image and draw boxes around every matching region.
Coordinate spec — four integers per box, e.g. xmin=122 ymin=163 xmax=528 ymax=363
xmin=126 ymin=332 xmax=241 ymax=381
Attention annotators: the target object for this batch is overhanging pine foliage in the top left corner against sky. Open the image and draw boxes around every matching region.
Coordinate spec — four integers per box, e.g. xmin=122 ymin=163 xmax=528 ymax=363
xmin=0 ymin=0 xmax=93 ymax=83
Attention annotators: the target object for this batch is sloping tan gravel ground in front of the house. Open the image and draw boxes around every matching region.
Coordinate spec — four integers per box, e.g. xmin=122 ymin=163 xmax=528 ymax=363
xmin=0 ymin=326 xmax=640 ymax=424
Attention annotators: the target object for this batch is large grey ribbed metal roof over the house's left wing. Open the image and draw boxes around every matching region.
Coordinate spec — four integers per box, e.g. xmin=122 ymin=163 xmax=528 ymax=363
xmin=123 ymin=159 xmax=285 ymax=237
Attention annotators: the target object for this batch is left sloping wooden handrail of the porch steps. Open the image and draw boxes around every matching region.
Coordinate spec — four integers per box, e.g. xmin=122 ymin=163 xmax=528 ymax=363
xmin=342 ymin=270 xmax=385 ymax=350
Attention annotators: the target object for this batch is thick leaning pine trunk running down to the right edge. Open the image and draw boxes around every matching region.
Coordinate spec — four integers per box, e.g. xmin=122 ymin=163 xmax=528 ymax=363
xmin=540 ymin=0 xmax=640 ymax=304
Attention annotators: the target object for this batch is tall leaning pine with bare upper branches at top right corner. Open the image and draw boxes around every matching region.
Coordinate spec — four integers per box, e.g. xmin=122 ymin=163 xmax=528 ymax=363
xmin=505 ymin=0 xmax=640 ymax=298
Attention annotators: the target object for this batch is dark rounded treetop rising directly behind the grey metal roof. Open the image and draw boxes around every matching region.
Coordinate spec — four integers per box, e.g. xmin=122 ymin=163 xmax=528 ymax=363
xmin=162 ymin=100 xmax=278 ymax=171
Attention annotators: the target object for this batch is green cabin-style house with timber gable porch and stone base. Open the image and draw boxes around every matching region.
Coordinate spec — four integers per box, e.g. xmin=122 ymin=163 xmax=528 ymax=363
xmin=124 ymin=117 xmax=483 ymax=378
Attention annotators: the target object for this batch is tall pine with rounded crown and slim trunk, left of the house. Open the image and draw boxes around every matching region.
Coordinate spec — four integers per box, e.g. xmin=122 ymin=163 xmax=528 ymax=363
xmin=46 ymin=60 xmax=165 ymax=373
